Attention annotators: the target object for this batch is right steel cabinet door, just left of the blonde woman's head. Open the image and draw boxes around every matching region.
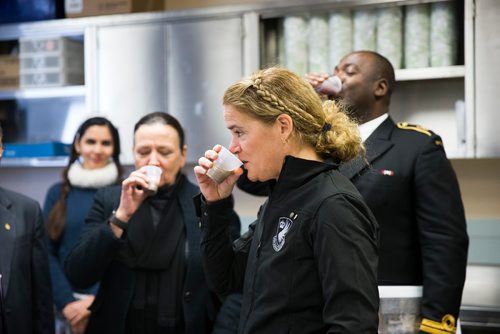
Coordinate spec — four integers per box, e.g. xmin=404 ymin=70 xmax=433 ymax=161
xmin=166 ymin=17 xmax=243 ymax=163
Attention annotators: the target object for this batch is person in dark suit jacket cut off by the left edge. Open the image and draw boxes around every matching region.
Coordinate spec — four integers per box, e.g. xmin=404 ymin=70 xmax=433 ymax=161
xmin=0 ymin=124 xmax=54 ymax=334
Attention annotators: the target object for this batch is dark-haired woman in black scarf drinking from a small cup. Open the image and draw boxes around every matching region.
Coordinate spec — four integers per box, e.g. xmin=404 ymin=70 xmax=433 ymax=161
xmin=65 ymin=112 xmax=239 ymax=334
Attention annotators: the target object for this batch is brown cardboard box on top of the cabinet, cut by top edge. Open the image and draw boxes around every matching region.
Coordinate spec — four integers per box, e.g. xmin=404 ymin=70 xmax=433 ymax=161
xmin=64 ymin=0 xmax=164 ymax=17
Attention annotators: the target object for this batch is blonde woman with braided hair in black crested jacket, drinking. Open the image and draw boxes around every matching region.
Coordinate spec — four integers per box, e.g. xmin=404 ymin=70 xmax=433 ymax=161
xmin=194 ymin=67 xmax=379 ymax=334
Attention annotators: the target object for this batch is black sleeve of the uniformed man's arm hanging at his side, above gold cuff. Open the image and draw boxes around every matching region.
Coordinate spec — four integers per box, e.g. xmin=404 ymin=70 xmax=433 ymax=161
xmin=414 ymin=135 xmax=469 ymax=323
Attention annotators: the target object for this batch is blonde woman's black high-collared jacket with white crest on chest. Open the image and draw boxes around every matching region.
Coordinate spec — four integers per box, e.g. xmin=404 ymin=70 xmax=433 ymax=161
xmin=198 ymin=156 xmax=379 ymax=334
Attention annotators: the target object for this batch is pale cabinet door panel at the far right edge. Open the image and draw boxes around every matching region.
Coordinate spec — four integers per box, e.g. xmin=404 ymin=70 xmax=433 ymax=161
xmin=474 ymin=0 xmax=500 ymax=158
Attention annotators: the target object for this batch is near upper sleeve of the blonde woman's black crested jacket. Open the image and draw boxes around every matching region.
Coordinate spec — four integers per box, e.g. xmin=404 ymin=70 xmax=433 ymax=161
xmin=311 ymin=195 xmax=379 ymax=334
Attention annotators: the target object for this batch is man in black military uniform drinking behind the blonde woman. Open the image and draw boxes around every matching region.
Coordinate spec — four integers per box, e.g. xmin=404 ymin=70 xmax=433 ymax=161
xmin=307 ymin=51 xmax=468 ymax=333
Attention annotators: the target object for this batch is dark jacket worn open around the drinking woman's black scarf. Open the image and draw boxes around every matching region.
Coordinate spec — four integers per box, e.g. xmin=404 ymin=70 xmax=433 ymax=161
xmin=65 ymin=175 xmax=239 ymax=334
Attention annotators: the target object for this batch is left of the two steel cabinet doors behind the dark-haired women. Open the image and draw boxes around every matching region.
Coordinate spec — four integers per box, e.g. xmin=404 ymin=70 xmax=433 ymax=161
xmin=96 ymin=23 xmax=165 ymax=163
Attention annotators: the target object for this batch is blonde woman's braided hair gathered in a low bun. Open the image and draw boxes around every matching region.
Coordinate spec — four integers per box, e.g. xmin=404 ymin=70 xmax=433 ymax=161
xmin=223 ymin=67 xmax=364 ymax=161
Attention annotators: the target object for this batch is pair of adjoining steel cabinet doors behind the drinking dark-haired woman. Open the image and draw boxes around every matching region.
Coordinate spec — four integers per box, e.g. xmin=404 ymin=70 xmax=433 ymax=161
xmin=95 ymin=15 xmax=250 ymax=163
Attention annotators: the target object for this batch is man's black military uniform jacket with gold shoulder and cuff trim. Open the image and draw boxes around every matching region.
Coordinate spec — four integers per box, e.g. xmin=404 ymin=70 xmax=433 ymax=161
xmin=340 ymin=118 xmax=468 ymax=333
